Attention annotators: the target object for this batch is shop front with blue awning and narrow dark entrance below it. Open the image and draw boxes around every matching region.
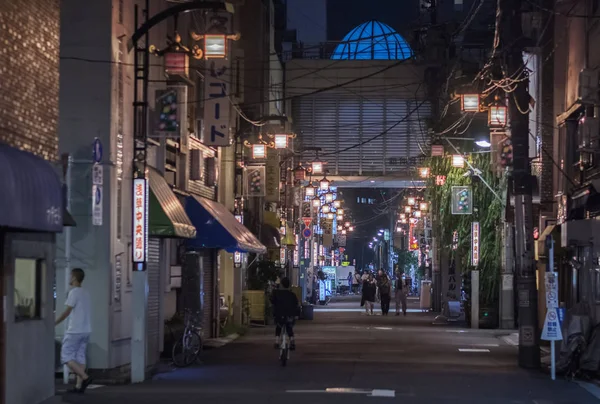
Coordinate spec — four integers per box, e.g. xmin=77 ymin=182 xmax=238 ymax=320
xmin=182 ymin=196 xmax=267 ymax=338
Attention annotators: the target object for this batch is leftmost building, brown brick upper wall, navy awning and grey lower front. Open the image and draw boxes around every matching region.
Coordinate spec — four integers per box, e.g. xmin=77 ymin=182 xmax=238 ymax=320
xmin=0 ymin=0 xmax=66 ymax=404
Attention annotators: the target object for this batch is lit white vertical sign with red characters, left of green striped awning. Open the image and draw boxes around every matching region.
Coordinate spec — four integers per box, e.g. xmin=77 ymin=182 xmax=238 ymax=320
xmin=133 ymin=178 xmax=148 ymax=270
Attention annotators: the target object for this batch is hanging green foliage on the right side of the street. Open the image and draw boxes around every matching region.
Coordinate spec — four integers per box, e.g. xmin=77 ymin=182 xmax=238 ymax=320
xmin=427 ymin=154 xmax=506 ymax=305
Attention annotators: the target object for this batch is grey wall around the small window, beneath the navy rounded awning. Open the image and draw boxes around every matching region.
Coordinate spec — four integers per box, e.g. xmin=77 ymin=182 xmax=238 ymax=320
xmin=0 ymin=233 xmax=55 ymax=404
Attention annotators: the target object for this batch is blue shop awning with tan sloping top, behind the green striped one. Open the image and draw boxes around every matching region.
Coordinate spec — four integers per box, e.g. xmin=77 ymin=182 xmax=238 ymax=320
xmin=185 ymin=196 xmax=267 ymax=254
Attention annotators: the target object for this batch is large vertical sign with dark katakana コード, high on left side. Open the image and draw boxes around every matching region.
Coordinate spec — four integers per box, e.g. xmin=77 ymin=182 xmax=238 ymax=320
xmin=203 ymin=58 xmax=231 ymax=147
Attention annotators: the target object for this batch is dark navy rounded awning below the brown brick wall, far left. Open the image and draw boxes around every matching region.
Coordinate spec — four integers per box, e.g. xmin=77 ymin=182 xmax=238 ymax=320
xmin=0 ymin=144 xmax=64 ymax=233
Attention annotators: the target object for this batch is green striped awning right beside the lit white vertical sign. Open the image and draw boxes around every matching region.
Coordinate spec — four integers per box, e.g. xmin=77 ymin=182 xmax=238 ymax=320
xmin=148 ymin=167 xmax=196 ymax=238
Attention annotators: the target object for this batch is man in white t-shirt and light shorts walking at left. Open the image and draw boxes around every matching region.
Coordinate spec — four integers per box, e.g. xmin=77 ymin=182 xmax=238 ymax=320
xmin=56 ymin=268 xmax=92 ymax=393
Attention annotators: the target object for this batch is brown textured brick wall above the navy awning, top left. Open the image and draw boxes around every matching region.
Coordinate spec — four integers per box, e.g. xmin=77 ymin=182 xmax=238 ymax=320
xmin=0 ymin=0 xmax=60 ymax=160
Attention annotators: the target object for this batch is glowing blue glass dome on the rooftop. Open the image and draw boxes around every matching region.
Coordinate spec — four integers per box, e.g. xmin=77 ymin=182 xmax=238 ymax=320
xmin=331 ymin=21 xmax=414 ymax=60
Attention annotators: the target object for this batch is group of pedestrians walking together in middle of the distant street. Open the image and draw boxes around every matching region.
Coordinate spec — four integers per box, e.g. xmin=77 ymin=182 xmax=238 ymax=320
xmin=360 ymin=269 xmax=410 ymax=316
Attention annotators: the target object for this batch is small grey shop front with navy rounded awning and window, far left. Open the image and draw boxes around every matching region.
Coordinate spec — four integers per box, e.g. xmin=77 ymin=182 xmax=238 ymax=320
xmin=0 ymin=145 xmax=68 ymax=404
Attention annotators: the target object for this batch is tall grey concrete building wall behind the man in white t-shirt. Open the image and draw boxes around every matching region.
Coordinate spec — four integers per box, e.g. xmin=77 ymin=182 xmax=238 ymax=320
xmin=57 ymin=0 xmax=167 ymax=369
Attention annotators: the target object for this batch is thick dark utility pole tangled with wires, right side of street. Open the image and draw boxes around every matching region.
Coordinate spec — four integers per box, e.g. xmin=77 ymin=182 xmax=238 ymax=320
xmin=496 ymin=0 xmax=540 ymax=369
